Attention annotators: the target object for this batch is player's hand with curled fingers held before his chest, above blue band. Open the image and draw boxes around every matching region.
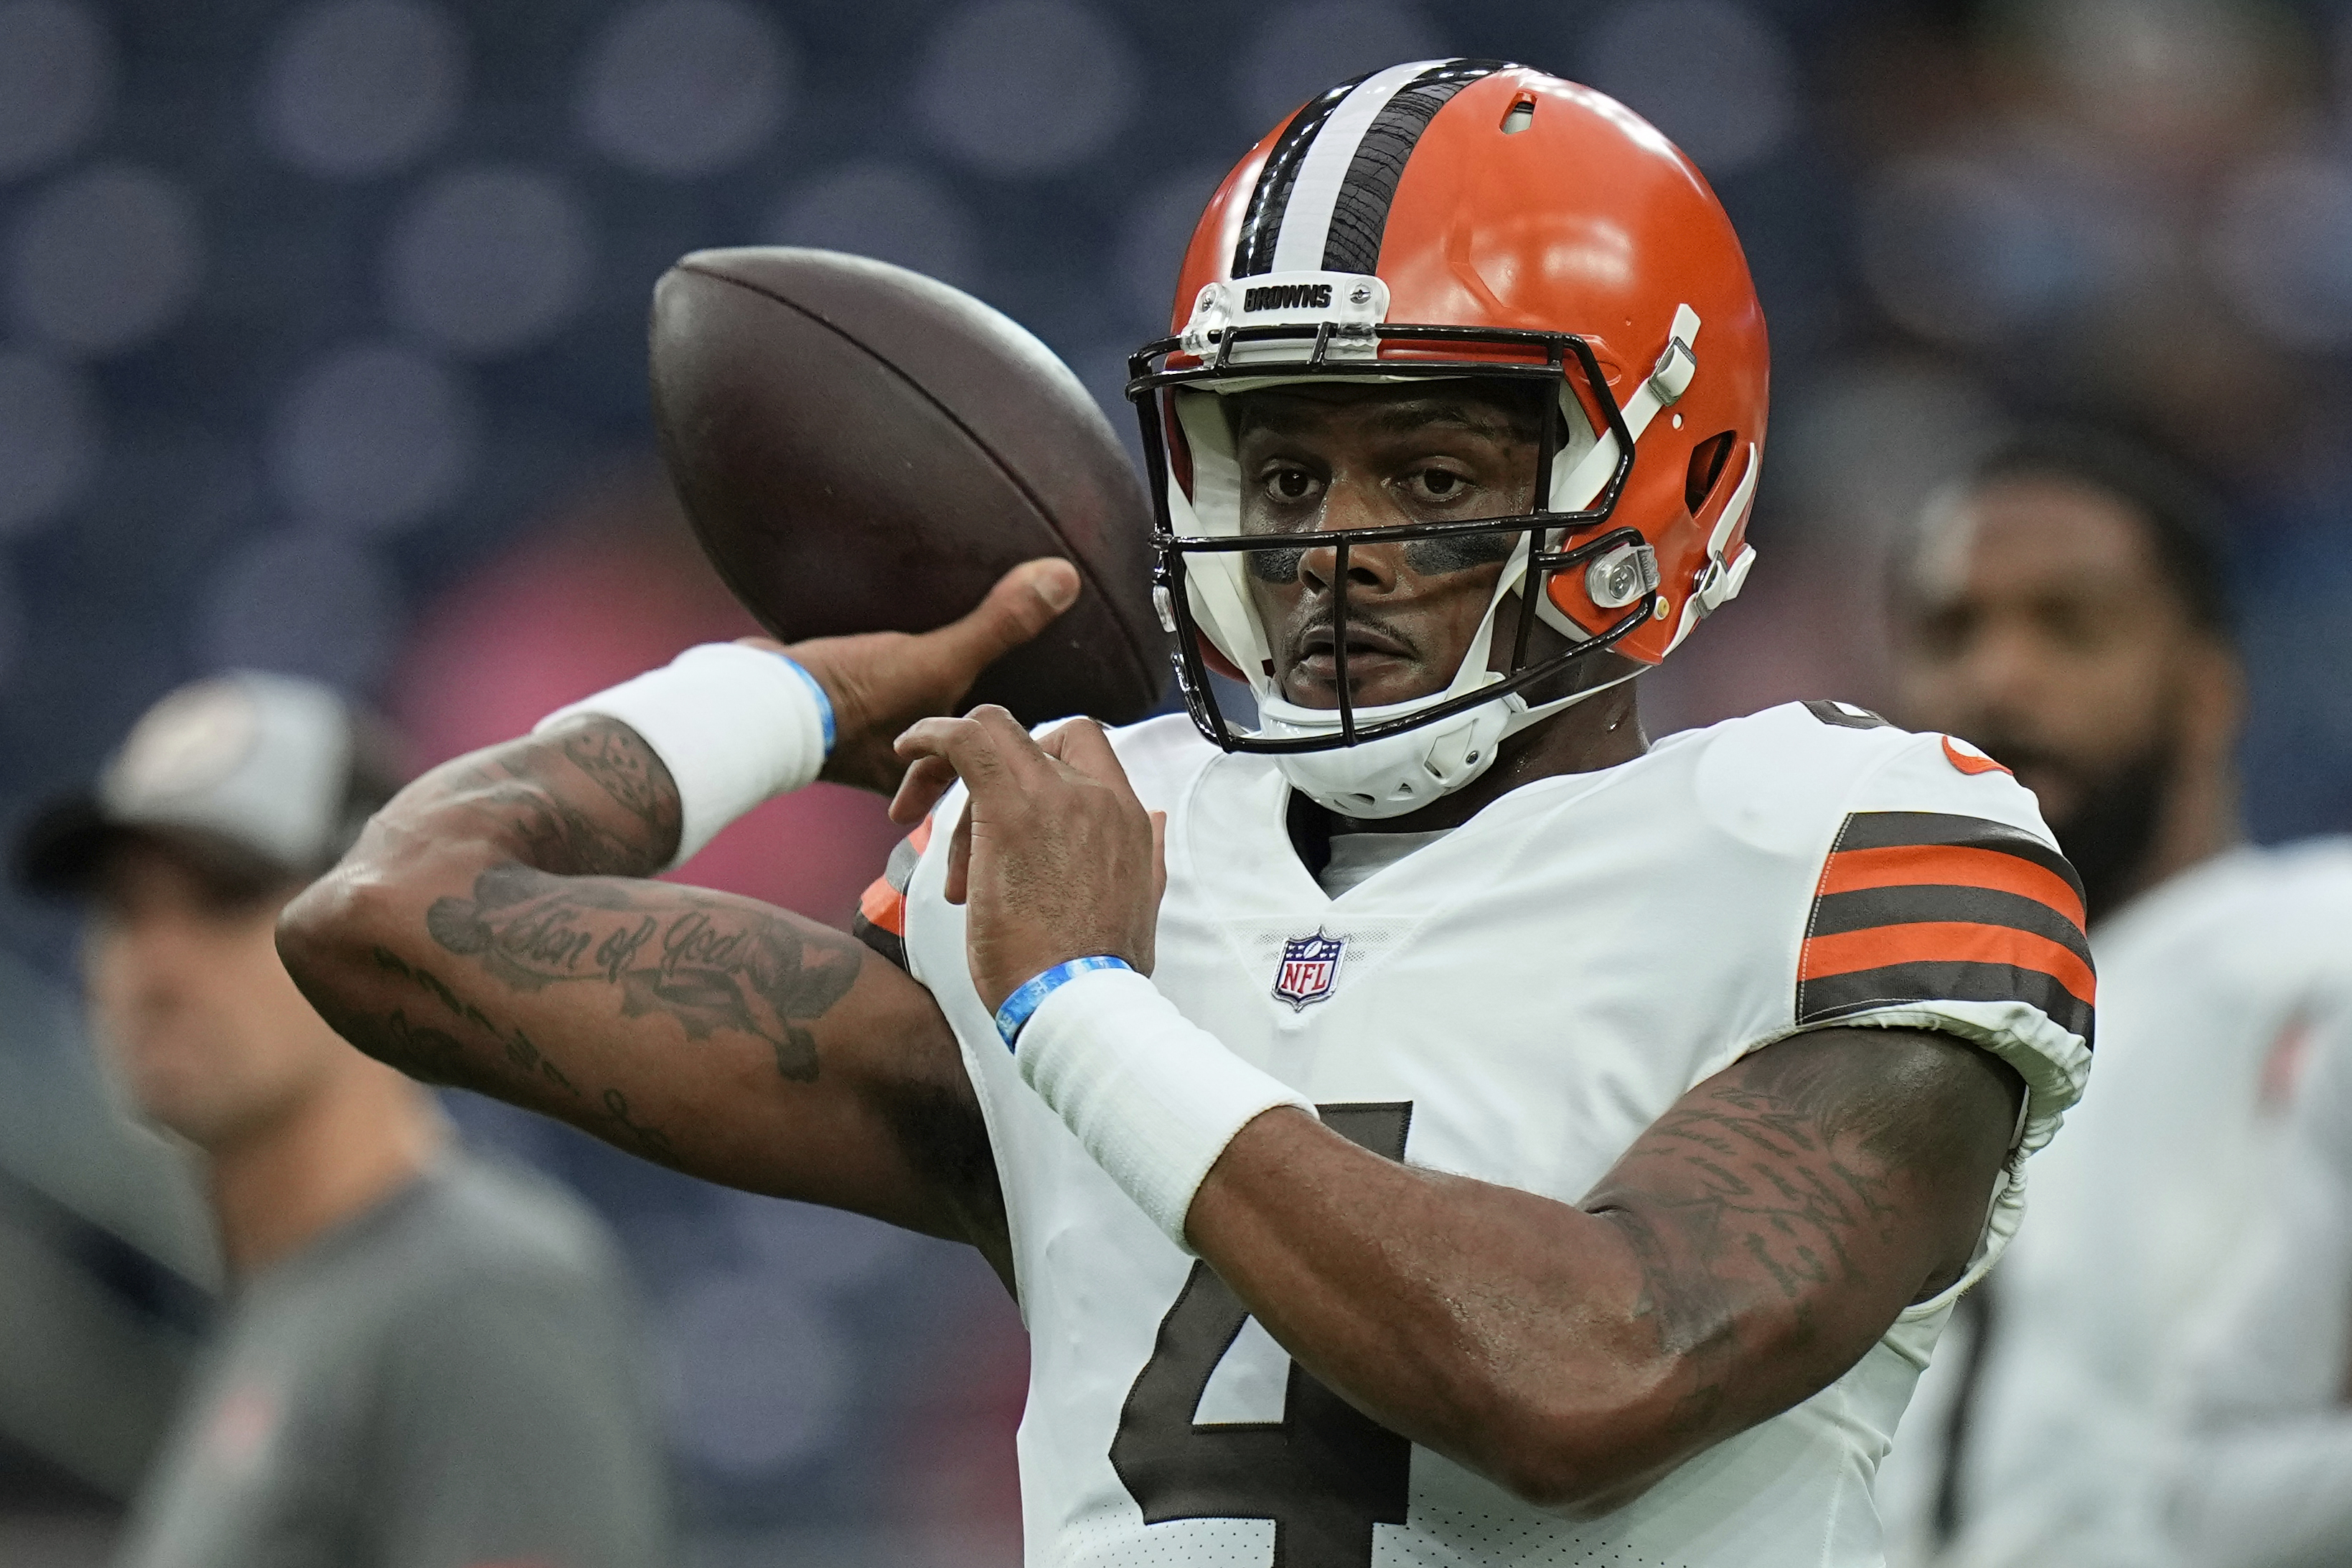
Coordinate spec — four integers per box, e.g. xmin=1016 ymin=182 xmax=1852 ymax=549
xmin=889 ymin=705 xmax=1166 ymax=1011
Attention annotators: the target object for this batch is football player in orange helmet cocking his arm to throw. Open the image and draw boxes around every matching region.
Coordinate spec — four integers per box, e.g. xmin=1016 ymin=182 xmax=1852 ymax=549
xmin=282 ymin=59 xmax=2094 ymax=1568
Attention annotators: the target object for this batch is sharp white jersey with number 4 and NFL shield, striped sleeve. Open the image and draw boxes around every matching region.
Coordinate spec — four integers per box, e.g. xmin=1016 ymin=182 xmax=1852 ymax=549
xmin=868 ymin=703 xmax=2091 ymax=1568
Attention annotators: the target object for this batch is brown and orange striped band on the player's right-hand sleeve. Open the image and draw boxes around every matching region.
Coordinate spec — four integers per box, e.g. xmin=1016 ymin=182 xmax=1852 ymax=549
xmin=1797 ymin=811 xmax=2098 ymax=1039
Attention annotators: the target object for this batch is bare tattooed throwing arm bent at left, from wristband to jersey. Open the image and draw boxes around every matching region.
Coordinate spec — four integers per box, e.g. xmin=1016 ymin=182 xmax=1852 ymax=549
xmin=296 ymin=717 xmax=983 ymax=1213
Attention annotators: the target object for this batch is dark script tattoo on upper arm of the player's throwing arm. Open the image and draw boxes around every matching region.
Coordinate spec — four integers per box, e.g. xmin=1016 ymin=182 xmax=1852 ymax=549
xmin=426 ymin=865 xmax=863 ymax=1081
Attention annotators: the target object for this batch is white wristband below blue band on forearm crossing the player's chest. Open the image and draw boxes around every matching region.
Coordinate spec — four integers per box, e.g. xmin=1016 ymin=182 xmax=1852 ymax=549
xmin=1013 ymin=969 xmax=1315 ymax=1251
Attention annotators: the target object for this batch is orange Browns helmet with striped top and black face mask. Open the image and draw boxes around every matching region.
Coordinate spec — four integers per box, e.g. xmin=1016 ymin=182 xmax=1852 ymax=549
xmin=1129 ymin=59 xmax=1766 ymax=816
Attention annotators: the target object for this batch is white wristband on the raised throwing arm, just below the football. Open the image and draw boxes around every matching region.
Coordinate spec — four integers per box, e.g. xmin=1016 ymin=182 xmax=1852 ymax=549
xmin=532 ymin=642 xmax=833 ymax=865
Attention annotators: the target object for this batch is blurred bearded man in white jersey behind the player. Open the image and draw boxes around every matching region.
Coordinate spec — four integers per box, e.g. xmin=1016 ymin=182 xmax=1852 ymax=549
xmin=1879 ymin=430 xmax=2352 ymax=1568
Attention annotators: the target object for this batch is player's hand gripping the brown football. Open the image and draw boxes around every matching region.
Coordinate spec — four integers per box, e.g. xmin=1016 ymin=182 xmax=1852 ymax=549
xmin=741 ymin=557 xmax=1079 ymax=794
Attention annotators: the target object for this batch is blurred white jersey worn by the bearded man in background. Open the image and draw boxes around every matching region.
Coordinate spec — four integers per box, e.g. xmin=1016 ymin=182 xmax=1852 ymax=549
xmin=1884 ymin=839 xmax=2352 ymax=1568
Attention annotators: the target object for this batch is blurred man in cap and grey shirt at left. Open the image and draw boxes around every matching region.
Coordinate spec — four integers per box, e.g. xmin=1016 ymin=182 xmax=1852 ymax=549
xmin=19 ymin=672 xmax=668 ymax=1568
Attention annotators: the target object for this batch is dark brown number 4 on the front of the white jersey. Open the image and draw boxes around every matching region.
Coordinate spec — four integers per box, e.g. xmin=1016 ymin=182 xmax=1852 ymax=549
xmin=1110 ymin=1102 xmax=1413 ymax=1568
